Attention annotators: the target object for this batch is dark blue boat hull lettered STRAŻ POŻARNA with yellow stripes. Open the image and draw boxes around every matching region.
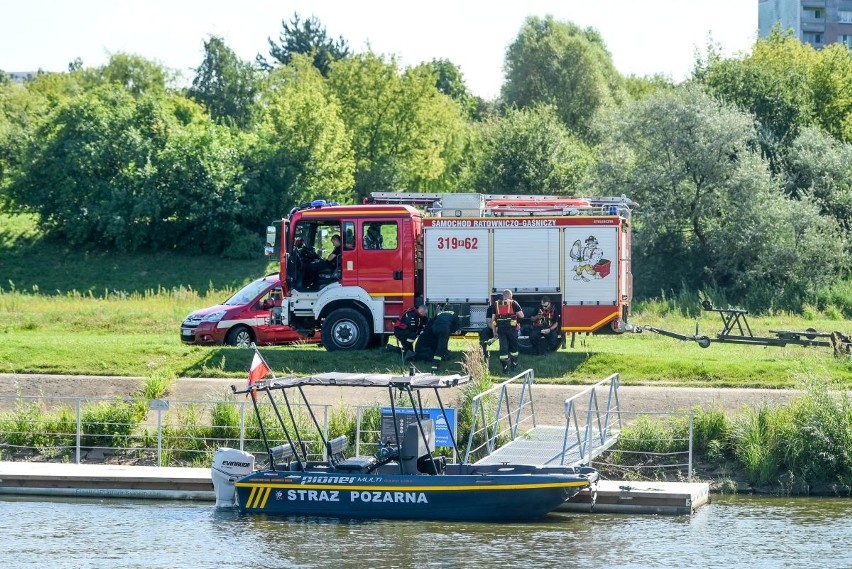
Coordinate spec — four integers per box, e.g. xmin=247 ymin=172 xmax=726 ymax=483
xmin=236 ymin=470 xmax=590 ymax=521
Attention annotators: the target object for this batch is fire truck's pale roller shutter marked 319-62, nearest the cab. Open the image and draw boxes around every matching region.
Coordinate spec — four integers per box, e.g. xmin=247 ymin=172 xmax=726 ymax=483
xmin=424 ymin=227 xmax=490 ymax=303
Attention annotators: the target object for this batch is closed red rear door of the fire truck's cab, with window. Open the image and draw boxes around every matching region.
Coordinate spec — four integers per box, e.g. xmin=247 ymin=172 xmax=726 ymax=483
xmin=354 ymin=219 xmax=403 ymax=299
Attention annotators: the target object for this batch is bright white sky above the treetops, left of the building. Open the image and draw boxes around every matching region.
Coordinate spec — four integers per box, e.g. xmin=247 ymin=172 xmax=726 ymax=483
xmin=0 ymin=0 xmax=757 ymax=99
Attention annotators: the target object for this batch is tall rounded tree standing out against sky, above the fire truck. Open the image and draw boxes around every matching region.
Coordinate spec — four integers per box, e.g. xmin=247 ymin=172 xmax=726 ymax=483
xmin=502 ymin=16 xmax=623 ymax=137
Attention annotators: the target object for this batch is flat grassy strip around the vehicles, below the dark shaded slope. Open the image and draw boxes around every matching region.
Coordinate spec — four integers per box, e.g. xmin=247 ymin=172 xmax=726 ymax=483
xmin=0 ymin=288 xmax=852 ymax=388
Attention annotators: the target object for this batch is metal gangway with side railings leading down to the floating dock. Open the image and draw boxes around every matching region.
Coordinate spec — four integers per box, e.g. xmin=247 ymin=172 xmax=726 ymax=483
xmin=464 ymin=369 xmax=622 ymax=466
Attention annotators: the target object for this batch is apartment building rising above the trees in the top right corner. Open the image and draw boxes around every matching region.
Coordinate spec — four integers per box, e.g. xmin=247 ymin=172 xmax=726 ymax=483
xmin=757 ymin=0 xmax=852 ymax=48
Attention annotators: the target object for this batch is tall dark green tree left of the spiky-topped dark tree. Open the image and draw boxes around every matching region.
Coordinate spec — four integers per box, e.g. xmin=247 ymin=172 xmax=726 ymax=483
xmin=187 ymin=36 xmax=259 ymax=128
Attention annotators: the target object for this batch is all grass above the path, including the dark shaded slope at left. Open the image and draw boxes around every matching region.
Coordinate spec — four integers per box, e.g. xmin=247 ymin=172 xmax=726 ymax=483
xmin=0 ymin=214 xmax=852 ymax=387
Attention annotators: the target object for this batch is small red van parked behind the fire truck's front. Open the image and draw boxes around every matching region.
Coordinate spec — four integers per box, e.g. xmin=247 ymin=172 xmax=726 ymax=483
xmin=180 ymin=273 xmax=320 ymax=347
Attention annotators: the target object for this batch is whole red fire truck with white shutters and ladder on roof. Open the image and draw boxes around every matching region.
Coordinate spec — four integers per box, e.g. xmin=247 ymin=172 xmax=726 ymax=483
xmin=266 ymin=192 xmax=636 ymax=351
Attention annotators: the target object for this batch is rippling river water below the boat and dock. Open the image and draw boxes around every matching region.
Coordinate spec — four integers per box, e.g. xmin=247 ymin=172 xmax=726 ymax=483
xmin=0 ymin=496 xmax=852 ymax=569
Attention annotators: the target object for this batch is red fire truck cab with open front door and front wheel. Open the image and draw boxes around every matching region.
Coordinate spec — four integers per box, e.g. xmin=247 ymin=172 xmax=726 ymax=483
xmin=267 ymin=200 xmax=423 ymax=350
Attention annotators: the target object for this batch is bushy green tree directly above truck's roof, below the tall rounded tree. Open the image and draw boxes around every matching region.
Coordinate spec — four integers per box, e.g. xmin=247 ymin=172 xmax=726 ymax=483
xmin=466 ymin=106 xmax=594 ymax=195
